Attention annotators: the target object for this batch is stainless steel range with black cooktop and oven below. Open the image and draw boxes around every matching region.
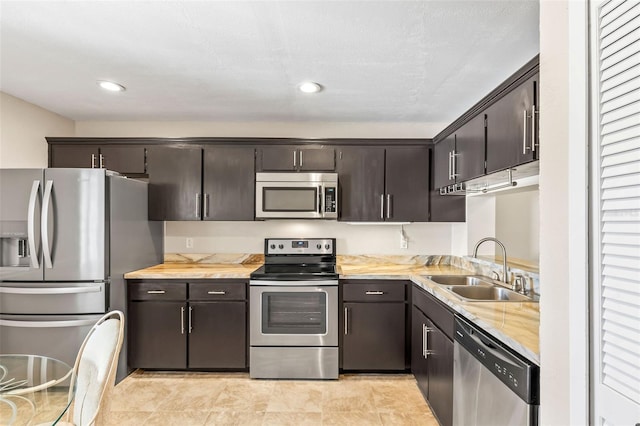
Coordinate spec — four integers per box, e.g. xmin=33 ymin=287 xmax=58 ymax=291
xmin=249 ymin=238 xmax=338 ymax=379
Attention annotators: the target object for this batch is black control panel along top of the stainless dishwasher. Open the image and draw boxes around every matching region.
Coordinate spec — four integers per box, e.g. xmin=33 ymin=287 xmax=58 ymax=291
xmin=455 ymin=317 xmax=540 ymax=404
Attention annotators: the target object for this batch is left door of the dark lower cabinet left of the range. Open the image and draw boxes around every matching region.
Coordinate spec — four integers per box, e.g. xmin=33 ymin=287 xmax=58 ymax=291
xmin=127 ymin=302 xmax=187 ymax=369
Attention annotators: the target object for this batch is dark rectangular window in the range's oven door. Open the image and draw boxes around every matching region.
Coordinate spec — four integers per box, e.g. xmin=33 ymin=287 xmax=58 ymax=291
xmin=262 ymin=291 xmax=327 ymax=334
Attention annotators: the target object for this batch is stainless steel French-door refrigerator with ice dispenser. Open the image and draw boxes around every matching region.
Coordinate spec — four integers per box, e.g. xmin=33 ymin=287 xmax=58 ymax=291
xmin=0 ymin=169 xmax=163 ymax=380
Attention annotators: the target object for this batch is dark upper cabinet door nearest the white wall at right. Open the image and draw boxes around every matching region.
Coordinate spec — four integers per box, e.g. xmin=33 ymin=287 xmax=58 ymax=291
xmin=487 ymin=74 xmax=538 ymax=173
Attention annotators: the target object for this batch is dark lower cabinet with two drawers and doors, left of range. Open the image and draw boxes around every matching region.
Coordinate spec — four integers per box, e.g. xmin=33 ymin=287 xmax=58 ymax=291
xmin=128 ymin=280 xmax=247 ymax=370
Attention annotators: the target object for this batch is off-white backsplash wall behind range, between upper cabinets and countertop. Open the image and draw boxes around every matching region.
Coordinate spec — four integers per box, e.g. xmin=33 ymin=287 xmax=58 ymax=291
xmin=165 ymin=220 xmax=464 ymax=255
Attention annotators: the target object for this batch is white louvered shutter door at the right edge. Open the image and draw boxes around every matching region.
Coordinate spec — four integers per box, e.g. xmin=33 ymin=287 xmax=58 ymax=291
xmin=592 ymin=0 xmax=640 ymax=424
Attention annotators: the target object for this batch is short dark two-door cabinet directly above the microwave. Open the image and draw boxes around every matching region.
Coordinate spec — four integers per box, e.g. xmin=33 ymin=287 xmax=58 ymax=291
xmin=256 ymin=146 xmax=336 ymax=172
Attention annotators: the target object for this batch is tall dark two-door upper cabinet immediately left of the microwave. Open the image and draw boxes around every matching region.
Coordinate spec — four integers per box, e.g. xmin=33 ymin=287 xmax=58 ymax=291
xmin=148 ymin=146 xmax=255 ymax=220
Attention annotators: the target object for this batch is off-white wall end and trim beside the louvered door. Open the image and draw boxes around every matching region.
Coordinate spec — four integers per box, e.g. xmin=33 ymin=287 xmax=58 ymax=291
xmin=540 ymin=1 xmax=590 ymax=425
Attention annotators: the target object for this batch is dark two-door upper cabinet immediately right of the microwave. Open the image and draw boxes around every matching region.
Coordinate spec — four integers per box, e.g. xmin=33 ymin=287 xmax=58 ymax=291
xmin=337 ymin=146 xmax=429 ymax=222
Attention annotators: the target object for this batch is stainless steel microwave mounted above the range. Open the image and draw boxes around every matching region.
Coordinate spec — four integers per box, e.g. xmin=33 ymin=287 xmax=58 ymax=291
xmin=256 ymin=173 xmax=338 ymax=219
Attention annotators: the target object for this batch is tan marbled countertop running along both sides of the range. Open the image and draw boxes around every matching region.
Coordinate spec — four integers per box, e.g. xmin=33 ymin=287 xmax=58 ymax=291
xmin=124 ymin=262 xmax=540 ymax=364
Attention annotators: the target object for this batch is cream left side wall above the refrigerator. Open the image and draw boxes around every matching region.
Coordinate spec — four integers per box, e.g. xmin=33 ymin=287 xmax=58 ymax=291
xmin=0 ymin=92 xmax=75 ymax=168
